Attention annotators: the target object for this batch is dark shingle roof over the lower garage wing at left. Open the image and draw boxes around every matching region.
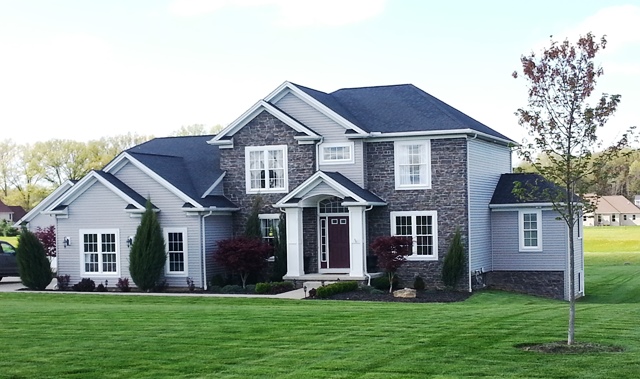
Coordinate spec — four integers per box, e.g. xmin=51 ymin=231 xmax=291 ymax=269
xmin=127 ymin=135 xmax=236 ymax=208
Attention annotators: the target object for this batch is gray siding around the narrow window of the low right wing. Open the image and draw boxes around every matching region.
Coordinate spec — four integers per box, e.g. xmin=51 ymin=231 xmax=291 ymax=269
xmin=491 ymin=209 xmax=568 ymax=271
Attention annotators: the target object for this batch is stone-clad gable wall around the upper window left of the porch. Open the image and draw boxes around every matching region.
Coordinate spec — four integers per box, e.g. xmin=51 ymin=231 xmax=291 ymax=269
xmin=220 ymin=111 xmax=315 ymax=235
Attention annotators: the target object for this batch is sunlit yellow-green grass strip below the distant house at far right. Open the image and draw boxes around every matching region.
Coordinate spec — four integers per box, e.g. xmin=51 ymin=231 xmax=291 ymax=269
xmin=584 ymin=226 xmax=640 ymax=252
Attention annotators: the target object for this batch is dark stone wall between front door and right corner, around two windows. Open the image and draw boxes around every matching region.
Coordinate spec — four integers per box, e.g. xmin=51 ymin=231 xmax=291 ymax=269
xmin=365 ymin=138 xmax=469 ymax=289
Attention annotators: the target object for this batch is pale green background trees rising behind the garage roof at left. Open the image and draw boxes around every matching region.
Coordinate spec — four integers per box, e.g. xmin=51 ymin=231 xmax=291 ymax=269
xmin=0 ymin=124 xmax=222 ymax=211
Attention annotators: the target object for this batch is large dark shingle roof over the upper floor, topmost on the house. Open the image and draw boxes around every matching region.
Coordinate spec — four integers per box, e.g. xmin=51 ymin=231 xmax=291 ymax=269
xmin=295 ymin=84 xmax=510 ymax=140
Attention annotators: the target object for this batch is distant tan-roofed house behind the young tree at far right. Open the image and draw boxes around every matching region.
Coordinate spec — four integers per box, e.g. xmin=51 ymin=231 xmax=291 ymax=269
xmin=582 ymin=195 xmax=640 ymax=226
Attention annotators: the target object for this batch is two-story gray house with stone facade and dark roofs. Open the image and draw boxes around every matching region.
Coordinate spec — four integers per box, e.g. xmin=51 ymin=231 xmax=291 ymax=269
xmin=36 ymin=82 xmax=583 ymax=299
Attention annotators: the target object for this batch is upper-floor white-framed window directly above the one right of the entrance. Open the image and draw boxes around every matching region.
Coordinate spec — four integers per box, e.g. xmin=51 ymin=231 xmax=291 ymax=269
xmin=394 ymin=140 xmax=431 ymax=190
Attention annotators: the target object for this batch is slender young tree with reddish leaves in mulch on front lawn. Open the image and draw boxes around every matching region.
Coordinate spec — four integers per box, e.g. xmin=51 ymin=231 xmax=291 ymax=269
xmin=513 ymin=33 xmax=632 ymax=345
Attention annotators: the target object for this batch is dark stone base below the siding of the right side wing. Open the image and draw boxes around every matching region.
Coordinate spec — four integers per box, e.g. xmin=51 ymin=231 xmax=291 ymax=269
xmin=486 ymin=271 xmax=564 ymax=300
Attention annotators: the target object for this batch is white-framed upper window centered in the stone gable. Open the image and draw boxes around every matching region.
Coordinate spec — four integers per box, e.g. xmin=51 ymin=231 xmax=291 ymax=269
xmin=244 ymin=145 xmax=289 ymax=193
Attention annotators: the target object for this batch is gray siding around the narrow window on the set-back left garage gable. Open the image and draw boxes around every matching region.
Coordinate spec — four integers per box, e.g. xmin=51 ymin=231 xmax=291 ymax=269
xmin=115 ymin=163 xmax=204 ymax=287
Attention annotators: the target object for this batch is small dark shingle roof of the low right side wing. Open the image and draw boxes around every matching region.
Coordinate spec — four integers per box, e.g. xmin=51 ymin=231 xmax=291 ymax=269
xmin=490 ymin=173 xmax=579 ymax=204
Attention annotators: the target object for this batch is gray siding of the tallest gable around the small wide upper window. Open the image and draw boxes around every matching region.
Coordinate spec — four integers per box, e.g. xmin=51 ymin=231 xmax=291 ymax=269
xmin=276 ymin=93 xmax=365 ymax=186
